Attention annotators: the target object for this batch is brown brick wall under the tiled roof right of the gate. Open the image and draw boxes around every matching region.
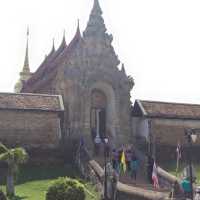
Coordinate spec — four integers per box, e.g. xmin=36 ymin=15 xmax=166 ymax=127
xmin=150 ymin=118 xmax=200 ymax=163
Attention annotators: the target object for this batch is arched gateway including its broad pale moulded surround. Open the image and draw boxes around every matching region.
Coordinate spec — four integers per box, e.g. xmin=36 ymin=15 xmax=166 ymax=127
xmin=84 ymin=81 xmax=119 ymax=148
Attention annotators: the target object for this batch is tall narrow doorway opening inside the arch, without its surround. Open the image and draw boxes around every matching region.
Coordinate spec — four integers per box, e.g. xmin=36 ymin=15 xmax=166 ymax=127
xmin=90 ymin=88 xmax=107 ymax=140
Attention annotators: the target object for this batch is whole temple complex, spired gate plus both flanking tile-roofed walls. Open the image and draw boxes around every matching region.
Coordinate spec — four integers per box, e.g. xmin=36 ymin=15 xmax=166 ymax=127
xmin=0 ymin=0 xmax=200 ymax=163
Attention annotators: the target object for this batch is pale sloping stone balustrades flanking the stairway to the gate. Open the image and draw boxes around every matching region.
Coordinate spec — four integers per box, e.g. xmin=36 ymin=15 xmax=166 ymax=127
xmin=76 ymin=141 xmax=183 ymax=200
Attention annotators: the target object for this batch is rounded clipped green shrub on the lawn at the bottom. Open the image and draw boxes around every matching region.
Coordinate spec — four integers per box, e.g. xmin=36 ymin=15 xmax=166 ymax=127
xmin=46 ymin=177 xmax=85 ymax=200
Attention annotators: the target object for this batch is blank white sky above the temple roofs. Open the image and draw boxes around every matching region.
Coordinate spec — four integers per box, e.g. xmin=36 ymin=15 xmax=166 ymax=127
xmin=0 ymin=0 xmax=200 ymax=104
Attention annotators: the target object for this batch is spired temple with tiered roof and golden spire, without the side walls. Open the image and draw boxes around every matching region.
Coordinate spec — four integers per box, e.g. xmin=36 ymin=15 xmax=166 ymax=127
xmin=15 ymin=0 xmax=134 ymax=148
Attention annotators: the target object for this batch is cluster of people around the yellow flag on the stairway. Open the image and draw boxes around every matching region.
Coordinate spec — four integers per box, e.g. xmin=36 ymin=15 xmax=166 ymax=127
xmin=111 ymin=147 xmax=139 ymax=180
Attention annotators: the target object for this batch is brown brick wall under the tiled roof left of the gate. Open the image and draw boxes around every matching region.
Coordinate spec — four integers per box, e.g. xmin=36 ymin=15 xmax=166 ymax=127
xmin=0 ymin=110 xmax=62 ymax=148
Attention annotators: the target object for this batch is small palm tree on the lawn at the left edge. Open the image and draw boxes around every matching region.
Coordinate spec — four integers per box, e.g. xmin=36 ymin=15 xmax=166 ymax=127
xmin=0 ymin=143 xmax=28 ymax=196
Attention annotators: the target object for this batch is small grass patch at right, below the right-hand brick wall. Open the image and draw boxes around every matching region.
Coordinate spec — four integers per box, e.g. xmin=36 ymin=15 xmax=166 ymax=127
xmin=161 ymin=162 xmax=200 ymax=185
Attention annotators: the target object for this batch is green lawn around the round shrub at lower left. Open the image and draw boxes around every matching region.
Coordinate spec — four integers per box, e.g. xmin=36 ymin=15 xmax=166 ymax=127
xmin=1 ymin=166 xmax=100 ymax=200
